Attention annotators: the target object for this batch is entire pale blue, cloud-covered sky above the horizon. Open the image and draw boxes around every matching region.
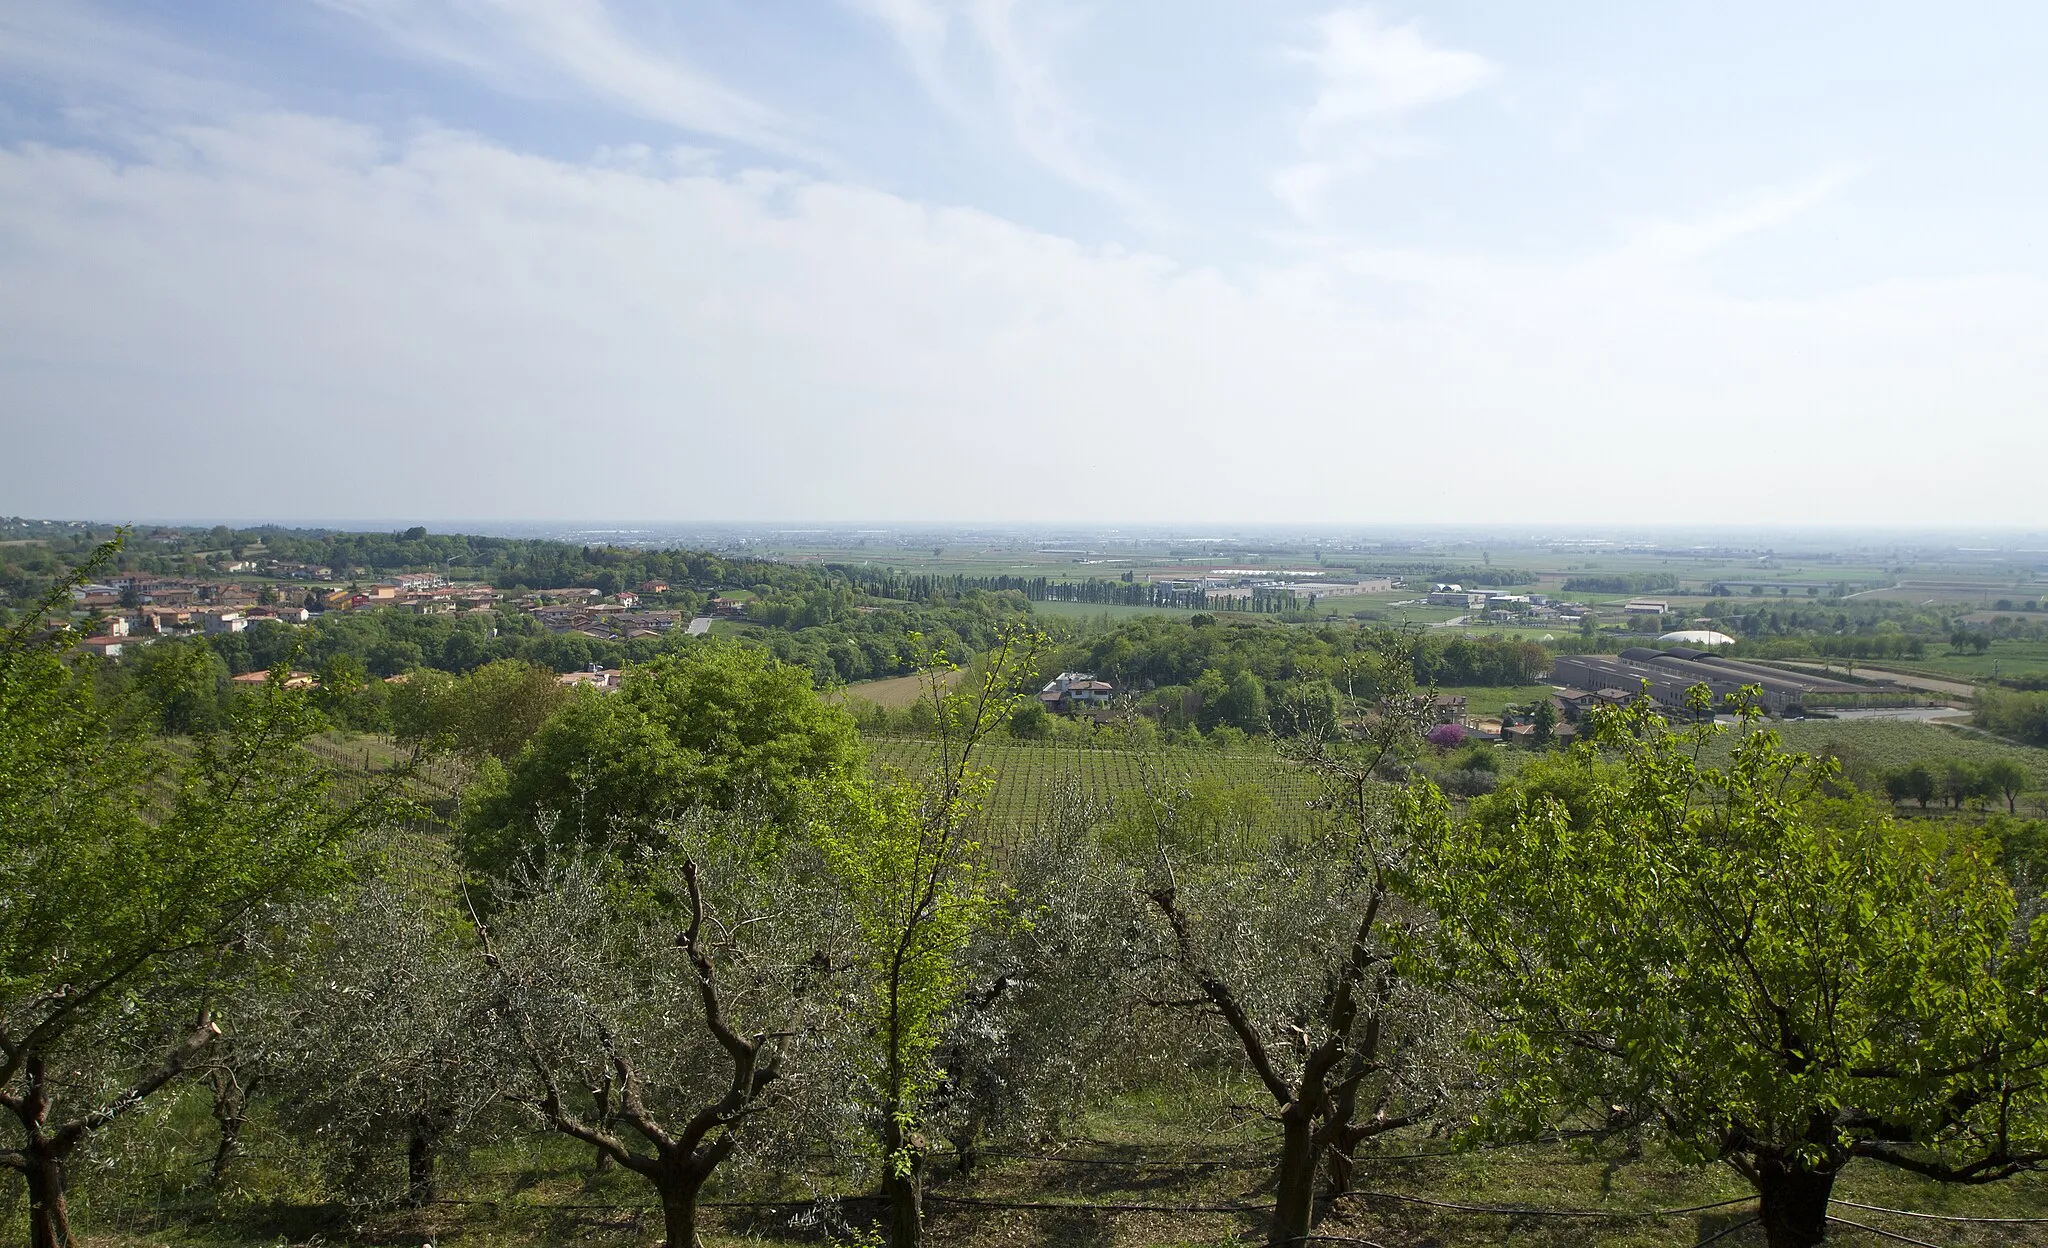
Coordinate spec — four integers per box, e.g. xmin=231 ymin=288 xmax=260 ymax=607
xmin=0 ymin=0 xmax=2048 ymax=529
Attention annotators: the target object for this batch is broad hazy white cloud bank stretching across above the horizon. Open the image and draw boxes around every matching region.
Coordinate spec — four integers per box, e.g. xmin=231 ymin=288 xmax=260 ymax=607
xmin=0 ymin=115 xmax=2048 ymax=525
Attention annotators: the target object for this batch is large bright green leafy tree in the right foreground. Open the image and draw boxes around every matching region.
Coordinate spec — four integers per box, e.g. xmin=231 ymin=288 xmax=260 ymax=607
xmin=1407 ymin=687 xmax=2048 ymax=1248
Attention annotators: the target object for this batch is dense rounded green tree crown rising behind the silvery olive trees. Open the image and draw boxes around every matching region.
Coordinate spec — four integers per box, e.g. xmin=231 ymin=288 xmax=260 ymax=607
xmin=463 ymin=641 xmax=860 ymax=873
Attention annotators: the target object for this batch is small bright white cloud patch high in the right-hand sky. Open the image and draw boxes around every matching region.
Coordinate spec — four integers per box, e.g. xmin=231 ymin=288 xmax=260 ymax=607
xmin=1270 ymin=8 xmax=1497 ymax=219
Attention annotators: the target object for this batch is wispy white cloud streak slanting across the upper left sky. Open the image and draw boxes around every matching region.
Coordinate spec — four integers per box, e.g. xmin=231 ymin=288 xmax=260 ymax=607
xmin=322 ymin=0 xmax=823 ymax=164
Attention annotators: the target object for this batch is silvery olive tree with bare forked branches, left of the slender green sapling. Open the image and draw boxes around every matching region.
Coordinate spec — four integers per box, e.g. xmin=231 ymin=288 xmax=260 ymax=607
xmin=477 ymin=824 xmax=836 ymax=1248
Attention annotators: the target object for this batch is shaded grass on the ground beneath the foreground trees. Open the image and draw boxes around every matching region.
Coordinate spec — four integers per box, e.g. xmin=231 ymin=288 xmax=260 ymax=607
xmin=79 ymin=1073 xmax=2048 ymax=1248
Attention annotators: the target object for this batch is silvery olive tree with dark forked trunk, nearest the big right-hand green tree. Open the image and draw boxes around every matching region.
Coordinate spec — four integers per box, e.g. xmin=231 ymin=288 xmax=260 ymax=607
xmin=1137 ymin=633 xmax=1444 ymax=1244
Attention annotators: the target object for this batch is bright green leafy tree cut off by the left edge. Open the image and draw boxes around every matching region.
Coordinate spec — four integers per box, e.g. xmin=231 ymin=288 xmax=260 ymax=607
xmin=0 ymin=545 xmax=381 ymax=1248
